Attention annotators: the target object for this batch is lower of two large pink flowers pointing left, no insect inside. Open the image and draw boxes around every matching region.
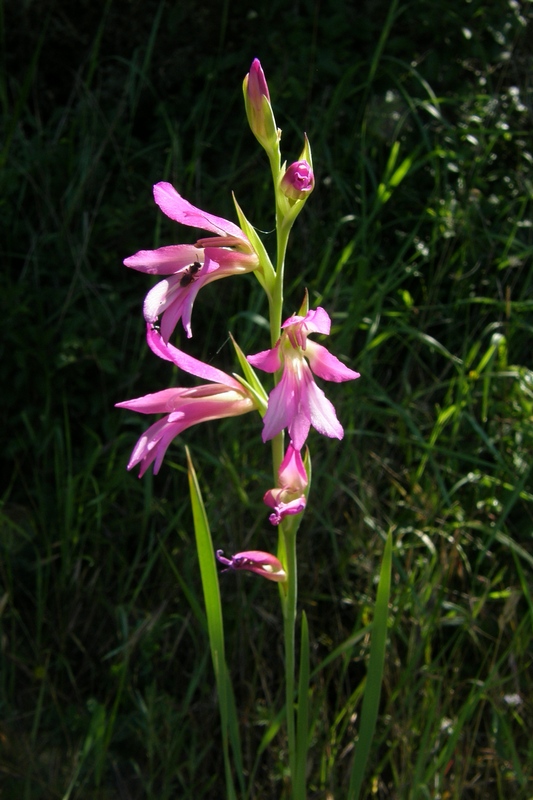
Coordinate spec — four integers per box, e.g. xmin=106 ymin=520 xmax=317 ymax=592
xmin=116 ymin=326 xmax=256 ymax=478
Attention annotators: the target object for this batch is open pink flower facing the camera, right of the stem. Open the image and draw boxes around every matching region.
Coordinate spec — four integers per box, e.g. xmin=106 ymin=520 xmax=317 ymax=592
xmin=248 ymin=308 xmax=359 ymax=450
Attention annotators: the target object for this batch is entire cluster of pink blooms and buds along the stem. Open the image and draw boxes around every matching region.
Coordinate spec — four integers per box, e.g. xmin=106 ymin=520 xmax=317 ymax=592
xmin=117 ymin=59 xmax=359 ymax=582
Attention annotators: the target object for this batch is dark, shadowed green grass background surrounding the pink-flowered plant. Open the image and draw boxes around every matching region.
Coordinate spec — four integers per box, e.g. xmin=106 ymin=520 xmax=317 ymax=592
xmin=0 ymin=0 xmax=533 ymax=800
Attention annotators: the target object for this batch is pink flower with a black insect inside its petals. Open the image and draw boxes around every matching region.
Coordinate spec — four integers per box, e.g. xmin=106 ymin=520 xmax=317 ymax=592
xmin=124 ymin=182 xmax=259 ymax=341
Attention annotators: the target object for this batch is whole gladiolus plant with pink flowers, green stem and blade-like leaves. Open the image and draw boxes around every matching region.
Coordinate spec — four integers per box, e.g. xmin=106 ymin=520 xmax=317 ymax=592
xmin=117 ymin=59 xmax=390 ymax=800
